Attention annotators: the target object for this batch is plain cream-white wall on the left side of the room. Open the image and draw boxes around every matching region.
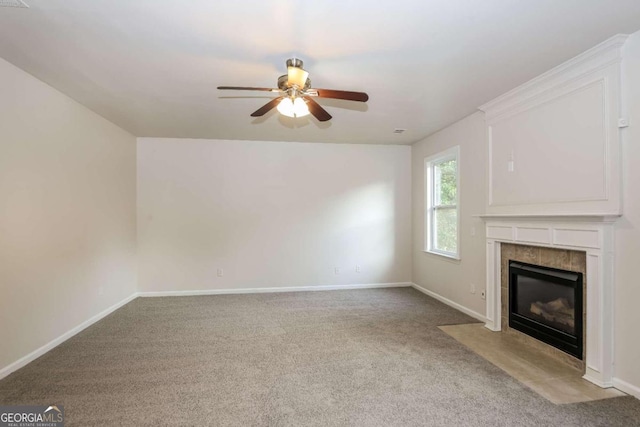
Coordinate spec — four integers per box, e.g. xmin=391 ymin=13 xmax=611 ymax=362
xmin=0 ymin=59 xmax=136 ymax=372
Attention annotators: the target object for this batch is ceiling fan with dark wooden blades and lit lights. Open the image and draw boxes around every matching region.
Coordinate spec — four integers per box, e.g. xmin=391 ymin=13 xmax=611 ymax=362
xmin=218 ymin=58 xmax=369 ymax=122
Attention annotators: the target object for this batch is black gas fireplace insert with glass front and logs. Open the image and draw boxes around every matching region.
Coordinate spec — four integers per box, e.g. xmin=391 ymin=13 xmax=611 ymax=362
xmin=509 ymin=260 xmax=583 ymax=360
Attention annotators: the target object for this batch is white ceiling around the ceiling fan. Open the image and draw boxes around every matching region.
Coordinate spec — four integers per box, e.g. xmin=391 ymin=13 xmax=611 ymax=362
xmin=0 ymin=0 xmax=640 ymax=144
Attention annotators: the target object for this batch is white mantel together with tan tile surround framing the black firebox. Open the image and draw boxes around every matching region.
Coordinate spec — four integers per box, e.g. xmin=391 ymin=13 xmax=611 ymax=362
xmin=484 ymin=216 xmax=616 ymax=387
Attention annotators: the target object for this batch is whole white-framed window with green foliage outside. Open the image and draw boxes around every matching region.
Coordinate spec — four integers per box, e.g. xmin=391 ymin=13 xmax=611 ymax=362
xmin=424 ymin=146 xmax=460 ymax=259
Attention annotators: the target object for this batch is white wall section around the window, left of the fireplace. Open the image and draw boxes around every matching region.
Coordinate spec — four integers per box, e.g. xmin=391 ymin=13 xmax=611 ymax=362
xmin=412 ymin=112 xmax=486 ymax=315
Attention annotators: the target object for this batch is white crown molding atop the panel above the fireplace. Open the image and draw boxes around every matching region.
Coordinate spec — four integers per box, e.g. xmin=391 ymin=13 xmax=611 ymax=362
xmin=478 ymin=34 xmax=629 ymax=121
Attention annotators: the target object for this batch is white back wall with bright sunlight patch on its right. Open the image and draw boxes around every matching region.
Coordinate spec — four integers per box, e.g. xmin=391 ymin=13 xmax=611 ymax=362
xmin=138 ymin=138 xmax=411 ymax=291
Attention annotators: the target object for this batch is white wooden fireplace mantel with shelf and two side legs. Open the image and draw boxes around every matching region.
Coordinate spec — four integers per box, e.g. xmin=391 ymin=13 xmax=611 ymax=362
xmin=480 ymin=214 xmax=618 ymax=387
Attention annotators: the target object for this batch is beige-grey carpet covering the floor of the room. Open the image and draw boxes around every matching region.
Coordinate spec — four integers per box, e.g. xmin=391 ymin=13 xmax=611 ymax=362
xmin=0 ymin=288 xmax=640 ymax=427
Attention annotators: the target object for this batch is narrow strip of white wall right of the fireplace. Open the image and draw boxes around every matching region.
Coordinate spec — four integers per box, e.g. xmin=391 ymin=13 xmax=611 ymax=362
xmin=614 ymin=32 xmax=640 ymax=397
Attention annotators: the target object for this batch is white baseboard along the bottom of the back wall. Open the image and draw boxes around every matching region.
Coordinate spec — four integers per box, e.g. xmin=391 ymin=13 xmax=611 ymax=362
xmin=138 ymin=282 xmax=413 ymax=297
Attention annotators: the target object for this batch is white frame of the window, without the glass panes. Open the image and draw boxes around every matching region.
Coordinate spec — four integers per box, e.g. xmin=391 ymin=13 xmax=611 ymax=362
xmin=424 ymin=145 xmax=460 ymax=260
